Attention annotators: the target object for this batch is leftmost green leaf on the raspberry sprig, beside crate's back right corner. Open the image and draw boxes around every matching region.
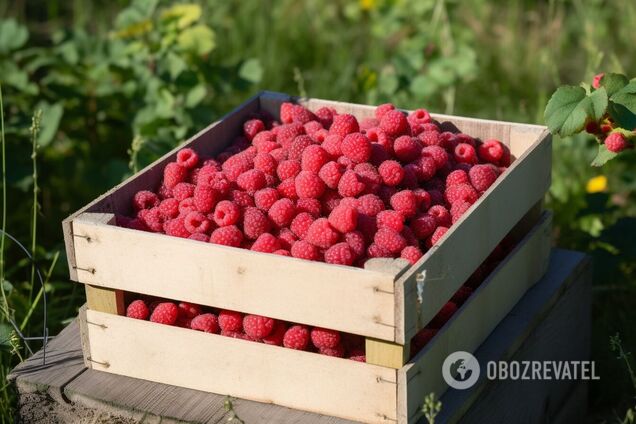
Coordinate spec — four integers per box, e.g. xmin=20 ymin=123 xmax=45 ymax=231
xmin=544 ymin=85 xmax=593 ymax=137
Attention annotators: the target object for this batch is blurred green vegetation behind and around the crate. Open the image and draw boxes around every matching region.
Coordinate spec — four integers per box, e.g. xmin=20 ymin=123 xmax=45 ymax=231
xmin=0 ymin=0 xmax=636 ymax=422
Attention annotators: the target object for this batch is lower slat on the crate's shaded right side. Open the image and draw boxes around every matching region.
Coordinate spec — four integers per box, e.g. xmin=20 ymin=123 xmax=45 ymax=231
xmin=398 ymin=213 xmax=551 ymax=423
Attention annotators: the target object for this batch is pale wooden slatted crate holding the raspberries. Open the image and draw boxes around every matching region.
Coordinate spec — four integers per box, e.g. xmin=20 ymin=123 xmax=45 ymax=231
xmin=63 ymin=92 xmax=551 ymax=423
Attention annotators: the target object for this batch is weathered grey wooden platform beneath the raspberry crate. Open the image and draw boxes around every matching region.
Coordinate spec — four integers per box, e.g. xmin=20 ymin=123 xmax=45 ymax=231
xmin=10 ymin=249 xmax=590 ymax=424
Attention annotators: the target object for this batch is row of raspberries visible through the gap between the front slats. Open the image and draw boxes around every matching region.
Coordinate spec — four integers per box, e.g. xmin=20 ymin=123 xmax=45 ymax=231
xmin=126 ymin=298 xmax=366 ymax=362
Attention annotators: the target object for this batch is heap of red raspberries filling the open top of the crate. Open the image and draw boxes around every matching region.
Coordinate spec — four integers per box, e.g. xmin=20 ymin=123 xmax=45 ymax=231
xmin=118 ymin=103 xmax=510 ymax=267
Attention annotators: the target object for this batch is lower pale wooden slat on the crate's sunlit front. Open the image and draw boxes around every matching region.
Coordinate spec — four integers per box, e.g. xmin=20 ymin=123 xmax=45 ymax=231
xmin=86 ymin=310 xmax=397 ymax=424
